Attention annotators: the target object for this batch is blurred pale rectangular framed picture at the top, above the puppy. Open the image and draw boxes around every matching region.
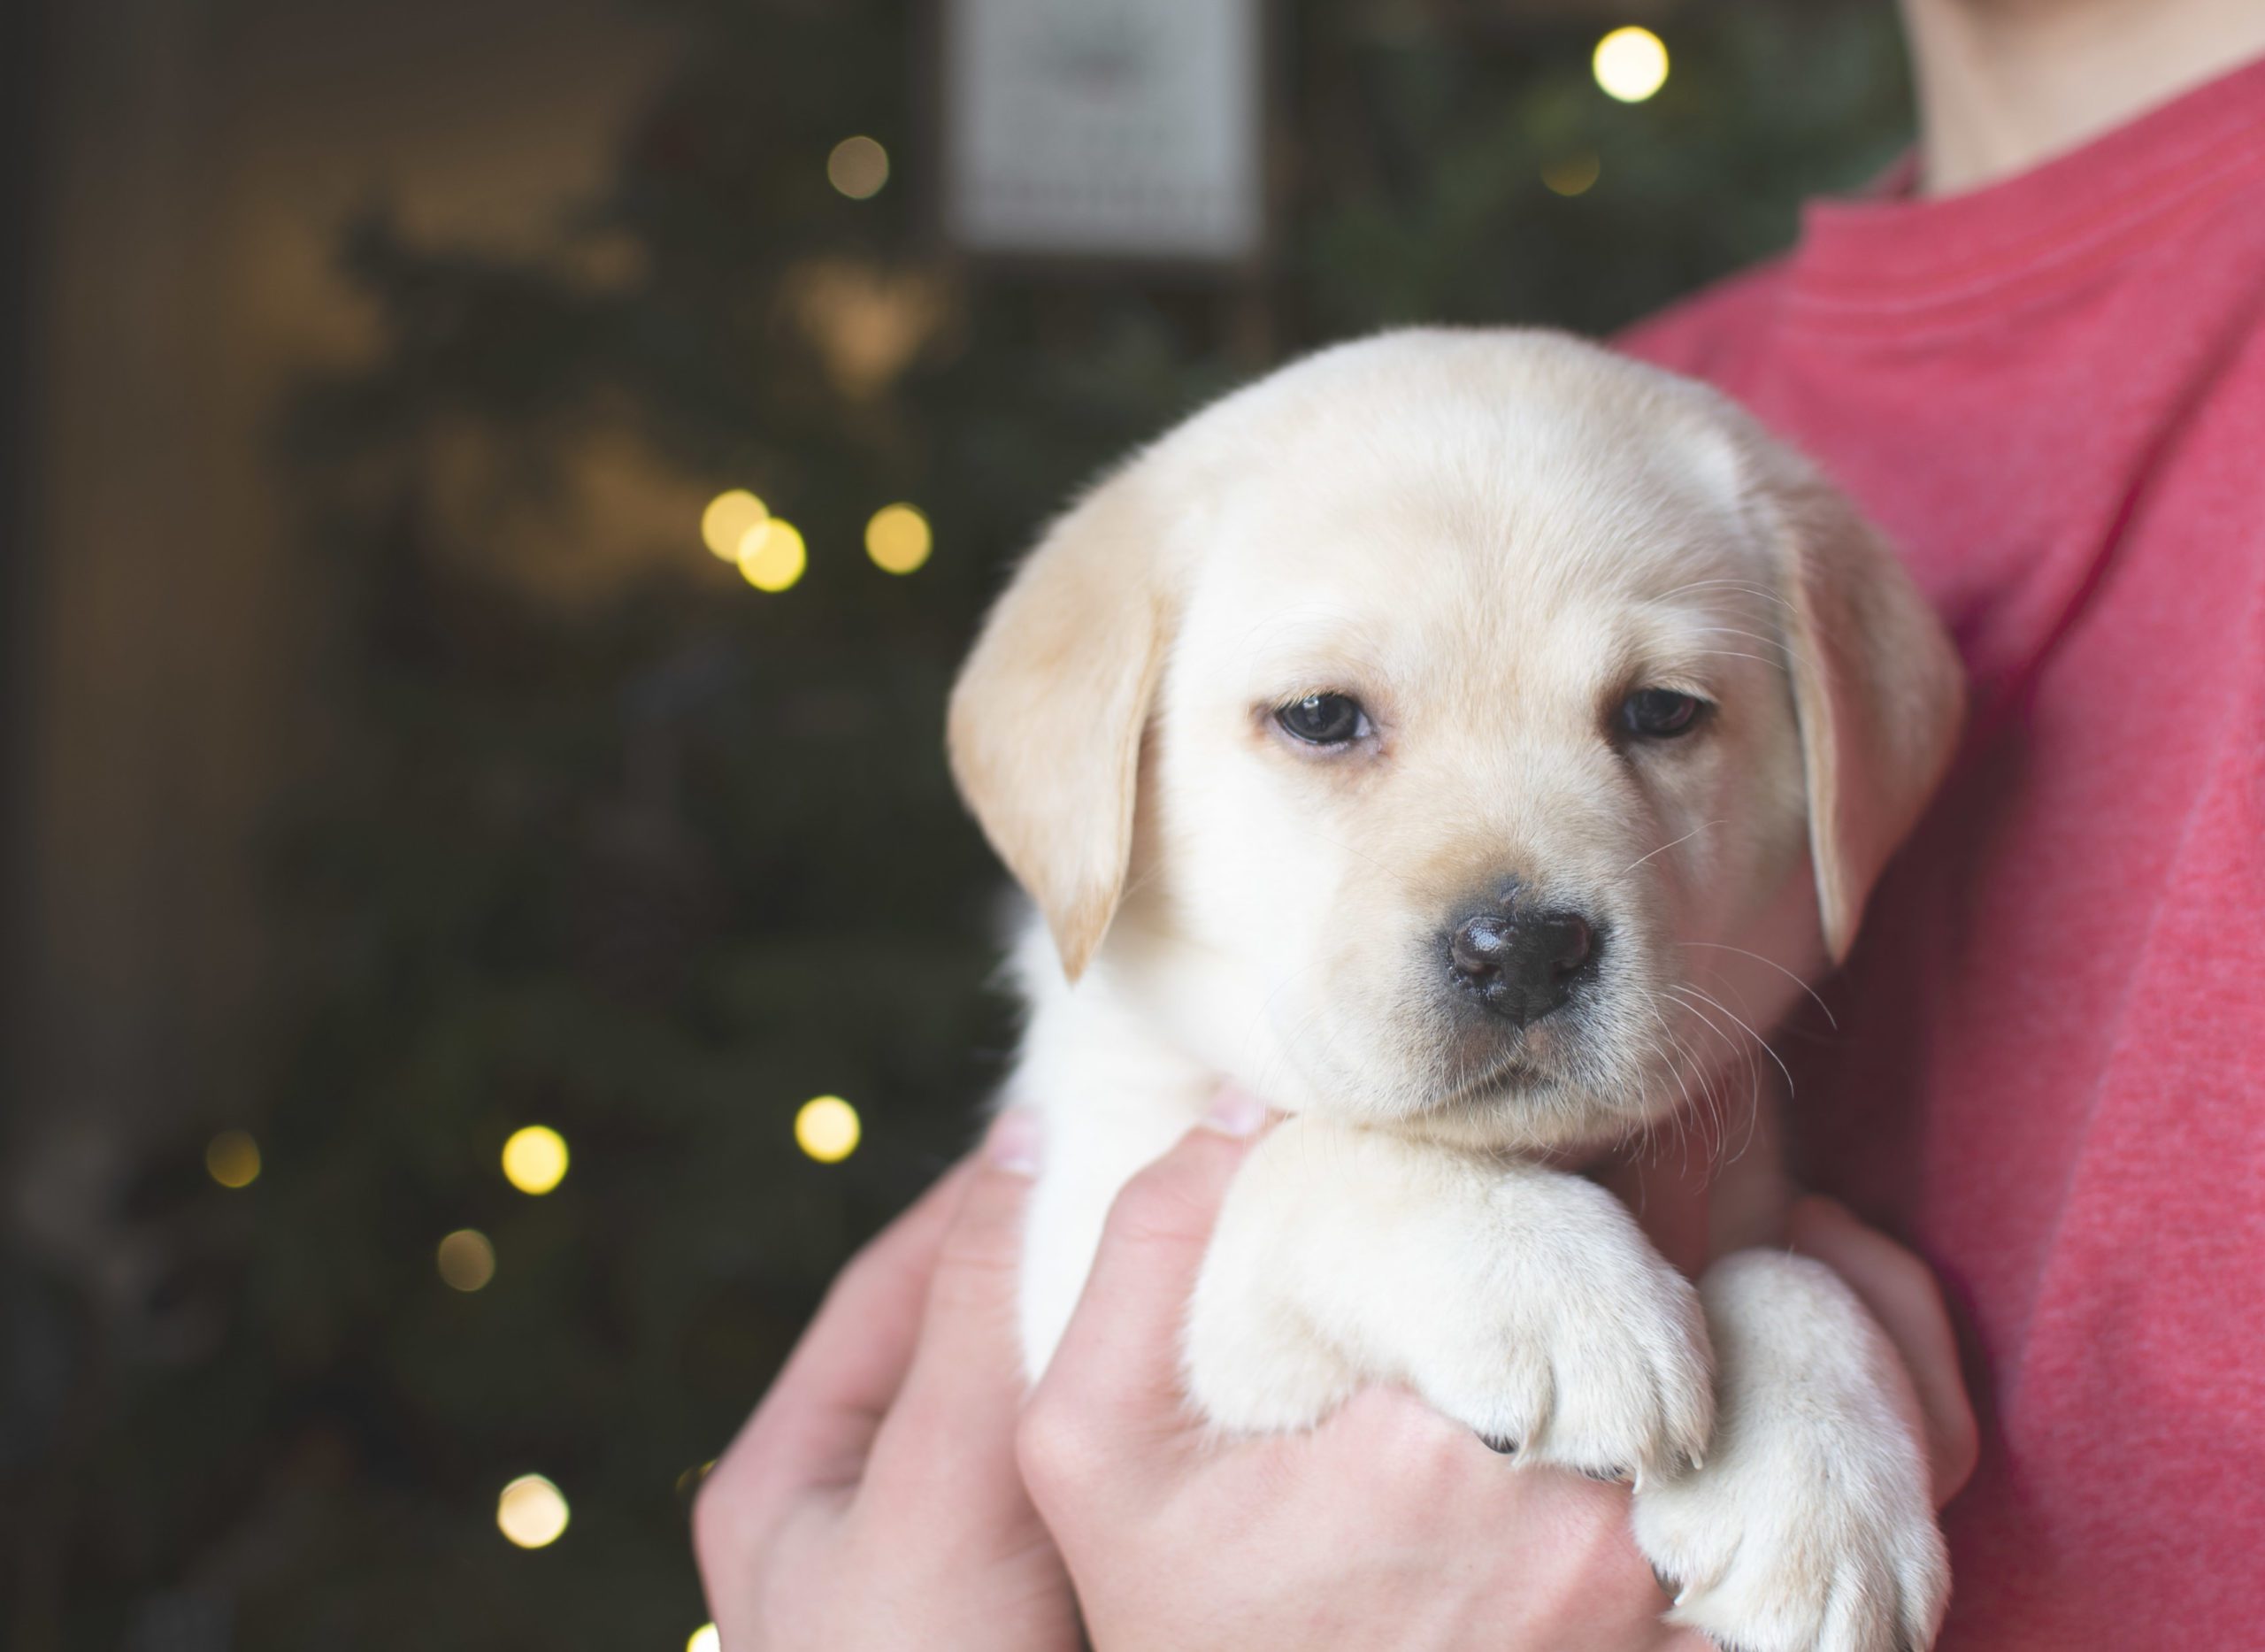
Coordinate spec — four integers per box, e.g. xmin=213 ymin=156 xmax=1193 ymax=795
xmin=940 ymin=0 xmax=1266 ymax=270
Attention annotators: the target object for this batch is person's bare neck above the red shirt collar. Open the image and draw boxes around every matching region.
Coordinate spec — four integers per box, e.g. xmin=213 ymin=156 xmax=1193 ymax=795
xmin=1902 ymin=0 xmax=2265 ymax=195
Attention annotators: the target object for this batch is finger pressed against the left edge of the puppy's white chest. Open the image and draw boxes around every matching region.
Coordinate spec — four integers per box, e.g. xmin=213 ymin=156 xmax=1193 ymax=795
xmin=867 ymin=1110 xmax=1040 ymax=1530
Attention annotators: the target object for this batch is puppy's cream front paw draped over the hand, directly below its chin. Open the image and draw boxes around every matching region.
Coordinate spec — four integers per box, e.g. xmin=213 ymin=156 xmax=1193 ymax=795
xmin=1185 ymin=1119 xmax=1715 ymax=1475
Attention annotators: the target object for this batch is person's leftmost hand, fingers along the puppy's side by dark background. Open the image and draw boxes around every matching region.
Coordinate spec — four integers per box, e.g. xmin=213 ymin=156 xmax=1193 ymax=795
xmin=693 ymin=1112 xmax=1080 ymax=1652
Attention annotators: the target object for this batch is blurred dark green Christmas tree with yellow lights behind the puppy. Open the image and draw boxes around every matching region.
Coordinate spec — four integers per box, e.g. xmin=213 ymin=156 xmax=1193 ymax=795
xmin=57 ymin=0 xmax=1905 ymax=1652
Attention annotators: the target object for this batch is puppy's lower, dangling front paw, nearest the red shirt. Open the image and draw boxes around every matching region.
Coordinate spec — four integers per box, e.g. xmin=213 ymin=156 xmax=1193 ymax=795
xmin=1635 ymin=1251 xmax=1950 ymax=1652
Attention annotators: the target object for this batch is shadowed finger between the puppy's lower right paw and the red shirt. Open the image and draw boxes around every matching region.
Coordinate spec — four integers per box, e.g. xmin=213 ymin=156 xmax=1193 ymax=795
xmin=1787 ymin=1195 xmax=1979 ymax=1505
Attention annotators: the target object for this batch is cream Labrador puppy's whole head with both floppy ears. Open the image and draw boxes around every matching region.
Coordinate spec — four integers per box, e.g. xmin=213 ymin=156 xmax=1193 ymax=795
xmin=951 ymin=333 xmax=1962 ymax=1147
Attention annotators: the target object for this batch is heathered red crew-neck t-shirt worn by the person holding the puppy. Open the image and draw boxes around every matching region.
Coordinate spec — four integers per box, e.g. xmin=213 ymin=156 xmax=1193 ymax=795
xmin=1624 ymin=51 xmax=2265 ymax=1652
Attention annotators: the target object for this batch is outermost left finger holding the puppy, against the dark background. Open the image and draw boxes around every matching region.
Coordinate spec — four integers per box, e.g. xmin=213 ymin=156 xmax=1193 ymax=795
xmin=700 ymin=1163 xmax=970 ymax=1516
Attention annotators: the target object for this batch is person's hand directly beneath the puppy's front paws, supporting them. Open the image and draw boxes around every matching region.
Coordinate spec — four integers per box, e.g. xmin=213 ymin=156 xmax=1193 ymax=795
xmin=1017 ymin=1096 xmax=1973 ymax=1652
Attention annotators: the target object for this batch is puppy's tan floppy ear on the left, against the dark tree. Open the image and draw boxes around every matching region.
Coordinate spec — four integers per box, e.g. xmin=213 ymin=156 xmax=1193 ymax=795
xmin=947 ymin=462 xmax=1166 ymax=981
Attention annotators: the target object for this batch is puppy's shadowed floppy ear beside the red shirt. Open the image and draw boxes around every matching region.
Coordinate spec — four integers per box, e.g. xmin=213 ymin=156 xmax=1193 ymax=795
xmin=1748 ymin=437 xmax=1966 ymax=963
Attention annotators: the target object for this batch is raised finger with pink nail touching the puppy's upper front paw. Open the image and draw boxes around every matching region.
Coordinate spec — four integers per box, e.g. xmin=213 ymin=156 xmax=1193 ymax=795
xmin=1040 ymin=1090 xmax=1266 ymax=1433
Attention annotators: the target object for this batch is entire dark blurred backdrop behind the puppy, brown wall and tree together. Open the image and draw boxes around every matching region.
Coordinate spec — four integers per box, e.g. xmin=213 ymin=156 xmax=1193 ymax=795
xmin=0 ymin=0 xmax=1908 ymax=1652
